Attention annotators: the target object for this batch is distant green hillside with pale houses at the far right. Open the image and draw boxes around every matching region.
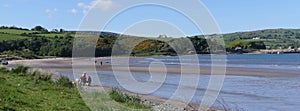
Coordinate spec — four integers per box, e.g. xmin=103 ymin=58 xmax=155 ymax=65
xmin=223 ymin=29 xmax=300 ymax=49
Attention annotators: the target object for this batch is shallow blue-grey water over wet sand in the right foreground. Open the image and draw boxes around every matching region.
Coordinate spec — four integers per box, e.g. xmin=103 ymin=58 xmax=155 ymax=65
xmin=58 ymin=71 xmax=300 ymax=111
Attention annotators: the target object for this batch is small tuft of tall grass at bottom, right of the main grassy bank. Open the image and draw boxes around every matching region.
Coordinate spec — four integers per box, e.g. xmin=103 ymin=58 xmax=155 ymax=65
xmin=109 ymin=88 xmax=151 ymax=109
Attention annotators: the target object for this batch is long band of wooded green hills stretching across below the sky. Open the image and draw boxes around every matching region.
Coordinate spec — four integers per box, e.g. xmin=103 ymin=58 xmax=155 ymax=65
xmin=0 ymin=26 xmax=300 ymax=59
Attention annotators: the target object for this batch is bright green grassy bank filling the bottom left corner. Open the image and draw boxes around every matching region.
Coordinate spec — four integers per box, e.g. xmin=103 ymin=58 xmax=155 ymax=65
xmin=0 ymin=66 xmax=90 ymax=111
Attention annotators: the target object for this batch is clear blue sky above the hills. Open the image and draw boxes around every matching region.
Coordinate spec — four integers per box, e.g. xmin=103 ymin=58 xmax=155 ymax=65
xmin=0 ymin=0 xmax=300 ymax=36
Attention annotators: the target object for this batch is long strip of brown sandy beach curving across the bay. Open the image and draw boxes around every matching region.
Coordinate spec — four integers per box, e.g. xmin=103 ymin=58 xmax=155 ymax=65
xmin=8 ymin=57 xmax=295 ymax=76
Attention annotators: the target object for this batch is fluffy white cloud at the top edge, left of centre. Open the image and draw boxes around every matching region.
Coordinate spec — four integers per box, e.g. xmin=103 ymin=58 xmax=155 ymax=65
xmin=77 ymin=0 xmax=117 ymax=14
